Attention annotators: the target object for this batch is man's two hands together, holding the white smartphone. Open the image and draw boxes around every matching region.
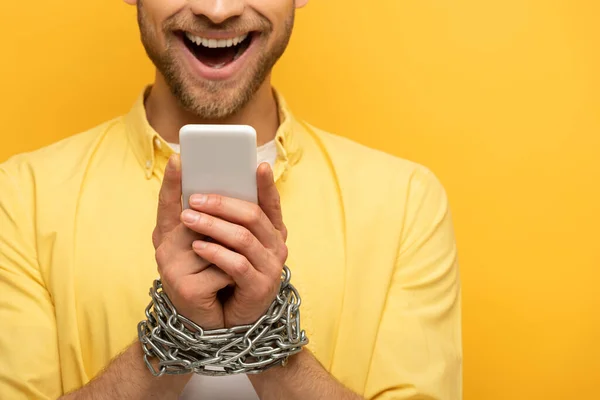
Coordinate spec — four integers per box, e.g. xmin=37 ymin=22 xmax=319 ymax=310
xmin=153 ymin=156 xmax=287 ymax=329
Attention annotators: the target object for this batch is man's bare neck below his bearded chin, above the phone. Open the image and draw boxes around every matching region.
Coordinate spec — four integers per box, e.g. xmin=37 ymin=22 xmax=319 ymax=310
xmin=145 ymin=72 xmax=279 ymax=146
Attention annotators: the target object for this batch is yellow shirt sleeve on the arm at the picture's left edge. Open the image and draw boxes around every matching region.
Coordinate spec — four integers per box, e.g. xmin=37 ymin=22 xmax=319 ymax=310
xmin=0 ymin=161 xmax=62 ymax=400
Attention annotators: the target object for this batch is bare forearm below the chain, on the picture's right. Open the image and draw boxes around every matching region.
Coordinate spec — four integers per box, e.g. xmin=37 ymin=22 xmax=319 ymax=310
xmin=249 ymin=349 xmax=362 ymax=400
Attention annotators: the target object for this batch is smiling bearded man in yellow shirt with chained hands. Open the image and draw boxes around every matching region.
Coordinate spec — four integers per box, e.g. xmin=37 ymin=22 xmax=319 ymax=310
xmin=0 ymin=0 xmax=462 ymax=400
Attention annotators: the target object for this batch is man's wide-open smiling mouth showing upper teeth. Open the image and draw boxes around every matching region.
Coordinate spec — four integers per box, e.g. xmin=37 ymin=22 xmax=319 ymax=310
xmin=182 ymin=32 xmax=253 ymax=69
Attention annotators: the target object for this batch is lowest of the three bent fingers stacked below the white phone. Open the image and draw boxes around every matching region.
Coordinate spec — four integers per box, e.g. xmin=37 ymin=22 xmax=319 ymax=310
xmin=193 ymin=240 xmax=259 ymax=289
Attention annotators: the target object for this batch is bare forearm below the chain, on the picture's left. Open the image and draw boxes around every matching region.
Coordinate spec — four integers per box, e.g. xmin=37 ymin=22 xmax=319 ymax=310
xmin=59 ymin=340 xmax=191 ymax=400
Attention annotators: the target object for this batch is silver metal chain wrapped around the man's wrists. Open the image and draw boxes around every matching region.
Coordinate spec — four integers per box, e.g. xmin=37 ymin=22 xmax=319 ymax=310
xmin=138 ymin=266 xmax=308 ymax=376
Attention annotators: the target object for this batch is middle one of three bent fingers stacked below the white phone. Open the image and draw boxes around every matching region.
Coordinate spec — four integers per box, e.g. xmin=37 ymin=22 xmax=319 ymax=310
xmin=182 ymin=210 xmax=269 ymax=270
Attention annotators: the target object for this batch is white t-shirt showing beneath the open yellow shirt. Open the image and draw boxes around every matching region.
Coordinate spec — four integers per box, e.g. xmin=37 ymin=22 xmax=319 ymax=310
xmin=169 ymin=140 xmax=277 ymax=400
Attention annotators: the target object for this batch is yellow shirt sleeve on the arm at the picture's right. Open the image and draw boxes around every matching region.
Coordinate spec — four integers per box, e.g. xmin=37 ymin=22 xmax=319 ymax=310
xmin=365 ymin=168 xmax=462 ymax=400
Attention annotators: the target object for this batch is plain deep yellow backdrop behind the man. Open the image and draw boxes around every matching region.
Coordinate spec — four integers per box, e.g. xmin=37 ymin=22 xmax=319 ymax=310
xmin=0 ymin=0 xmax=600 ymax=400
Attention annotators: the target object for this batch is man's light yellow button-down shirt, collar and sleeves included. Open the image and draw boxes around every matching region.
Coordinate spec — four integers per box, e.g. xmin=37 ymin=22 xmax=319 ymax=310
xmin=0 ymin=90 xmax=462 ymax=400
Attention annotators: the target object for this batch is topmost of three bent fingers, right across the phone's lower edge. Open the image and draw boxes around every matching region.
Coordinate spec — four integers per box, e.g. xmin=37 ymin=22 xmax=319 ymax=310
xmin=190 ymin=194 xmax=279 ymax=249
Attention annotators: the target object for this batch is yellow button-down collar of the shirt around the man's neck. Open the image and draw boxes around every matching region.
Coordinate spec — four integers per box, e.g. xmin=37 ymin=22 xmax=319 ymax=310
xmin=124 ymin=87 xmax=302 ymax=181
